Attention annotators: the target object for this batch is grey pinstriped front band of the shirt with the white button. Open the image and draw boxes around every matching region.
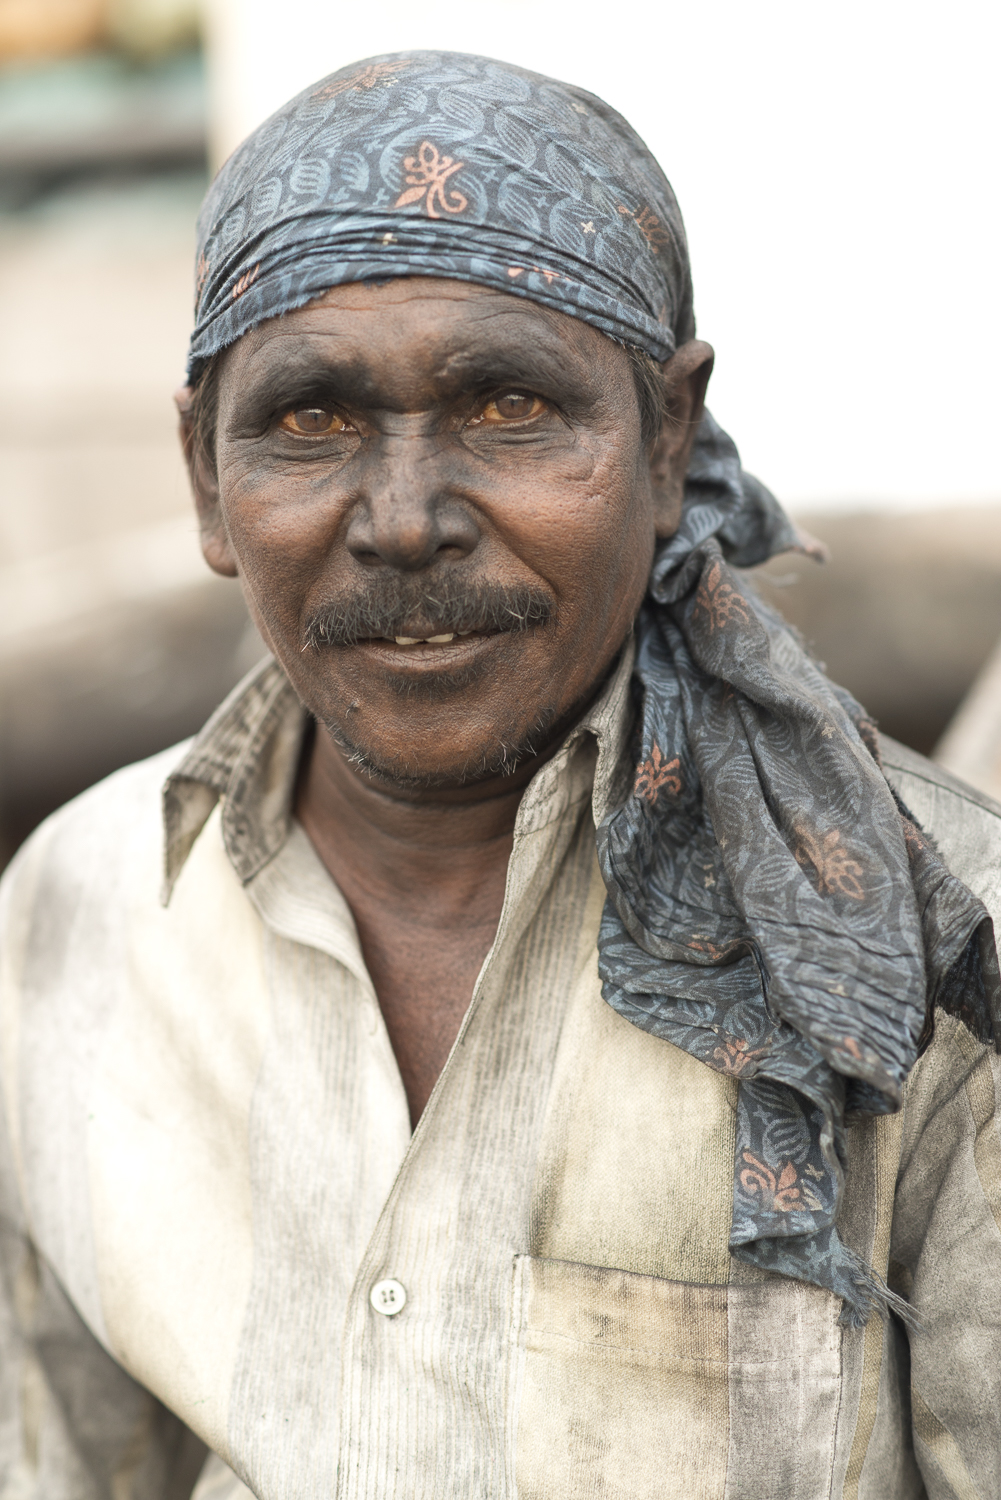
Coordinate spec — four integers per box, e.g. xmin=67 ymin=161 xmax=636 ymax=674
xmin=338 ymin=743 xmax=606 ymax=1500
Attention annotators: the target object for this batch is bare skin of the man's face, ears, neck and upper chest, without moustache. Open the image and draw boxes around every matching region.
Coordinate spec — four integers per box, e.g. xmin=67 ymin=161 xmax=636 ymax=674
xmin=179 ymin=278 xmax=713 ymax=1124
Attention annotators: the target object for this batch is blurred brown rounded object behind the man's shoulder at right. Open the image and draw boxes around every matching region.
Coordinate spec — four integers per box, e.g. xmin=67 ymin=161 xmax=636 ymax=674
xmin=752 ymin=507 xmax=1001 ymax=755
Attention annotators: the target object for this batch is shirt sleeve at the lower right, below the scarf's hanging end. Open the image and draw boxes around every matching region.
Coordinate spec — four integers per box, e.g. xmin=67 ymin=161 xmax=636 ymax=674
xmin=890 ymin=1013 xmax=1001 ymax=1500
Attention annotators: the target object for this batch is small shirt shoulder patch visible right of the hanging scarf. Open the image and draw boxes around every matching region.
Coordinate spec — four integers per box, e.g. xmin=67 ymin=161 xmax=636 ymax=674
xmin=881 ymin=735 xmax=1001 ymax=932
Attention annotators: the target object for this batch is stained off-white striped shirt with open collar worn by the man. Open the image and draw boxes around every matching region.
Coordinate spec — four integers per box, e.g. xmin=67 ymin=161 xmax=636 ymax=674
xmin=0 ymin=654 xmax=1001 ymax=1500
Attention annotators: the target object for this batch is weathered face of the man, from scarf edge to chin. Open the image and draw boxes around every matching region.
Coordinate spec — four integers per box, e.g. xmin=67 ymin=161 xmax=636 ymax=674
xmin=186 ymin=278 xmax=708 ymax=786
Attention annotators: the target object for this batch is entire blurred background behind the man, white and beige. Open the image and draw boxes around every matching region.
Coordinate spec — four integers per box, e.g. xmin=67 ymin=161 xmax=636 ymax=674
xmin=0 ymin=0 xmax=1001 ymax=864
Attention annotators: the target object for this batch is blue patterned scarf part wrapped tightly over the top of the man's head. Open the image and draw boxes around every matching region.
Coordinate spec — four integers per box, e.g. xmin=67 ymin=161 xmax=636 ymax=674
xmin=189 ymin=53 xmax=693 ymax=377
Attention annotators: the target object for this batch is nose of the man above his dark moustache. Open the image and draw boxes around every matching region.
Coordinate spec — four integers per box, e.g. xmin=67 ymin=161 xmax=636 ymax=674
xmin=347 ymin=435 xmax=480 ymax=572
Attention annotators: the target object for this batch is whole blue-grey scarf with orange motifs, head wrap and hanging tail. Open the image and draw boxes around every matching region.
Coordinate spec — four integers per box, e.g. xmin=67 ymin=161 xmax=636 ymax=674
xmin=189 ymin=53 xmax=1001 ymax=1325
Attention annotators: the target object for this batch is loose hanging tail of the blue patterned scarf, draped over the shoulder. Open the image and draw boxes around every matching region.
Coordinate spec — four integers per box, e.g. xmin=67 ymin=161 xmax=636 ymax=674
xmin=597 ymin=419 xmax=1001 ymax=1325
